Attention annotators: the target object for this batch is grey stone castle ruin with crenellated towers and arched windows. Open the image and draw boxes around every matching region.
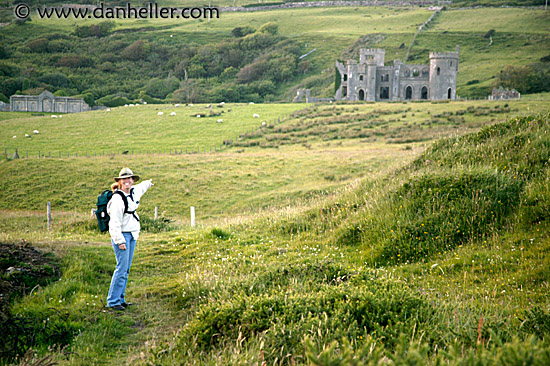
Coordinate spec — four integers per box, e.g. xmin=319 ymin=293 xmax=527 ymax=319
xmin=334 ymin=46 xmax=459 ymax=102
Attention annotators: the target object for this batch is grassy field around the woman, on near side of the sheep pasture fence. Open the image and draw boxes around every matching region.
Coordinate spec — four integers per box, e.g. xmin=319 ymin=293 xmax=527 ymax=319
xmin=0 ymin=95 xmax=550 ymax=365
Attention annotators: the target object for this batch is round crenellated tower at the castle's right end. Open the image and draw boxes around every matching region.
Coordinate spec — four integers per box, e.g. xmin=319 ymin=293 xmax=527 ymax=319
xmin=429 ymin=46 xmax=459 ymax=100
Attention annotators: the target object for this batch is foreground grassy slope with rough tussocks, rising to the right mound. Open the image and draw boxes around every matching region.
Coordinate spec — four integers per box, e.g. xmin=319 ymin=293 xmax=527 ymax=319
xmin=1 ymin=106 xmax=550 ymax=365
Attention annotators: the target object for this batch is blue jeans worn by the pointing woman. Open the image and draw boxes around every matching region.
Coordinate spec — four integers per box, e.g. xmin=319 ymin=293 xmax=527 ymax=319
xmin=107 ymin=233 xmax=136 ymax=307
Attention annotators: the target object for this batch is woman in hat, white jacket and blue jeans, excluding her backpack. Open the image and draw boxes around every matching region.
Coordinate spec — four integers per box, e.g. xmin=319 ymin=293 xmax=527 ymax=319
xmin=107 ymin=168 xmax=153 ymax=310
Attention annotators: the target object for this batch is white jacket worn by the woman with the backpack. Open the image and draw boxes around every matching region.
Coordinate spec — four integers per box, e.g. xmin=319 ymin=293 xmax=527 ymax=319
xmin=107 ymin=179 xmax=153 ymax=244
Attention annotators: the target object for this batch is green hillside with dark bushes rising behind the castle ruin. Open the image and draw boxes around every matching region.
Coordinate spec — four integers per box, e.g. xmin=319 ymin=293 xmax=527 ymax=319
xmin=0 ymin=7 xmax=550 ymax=104
